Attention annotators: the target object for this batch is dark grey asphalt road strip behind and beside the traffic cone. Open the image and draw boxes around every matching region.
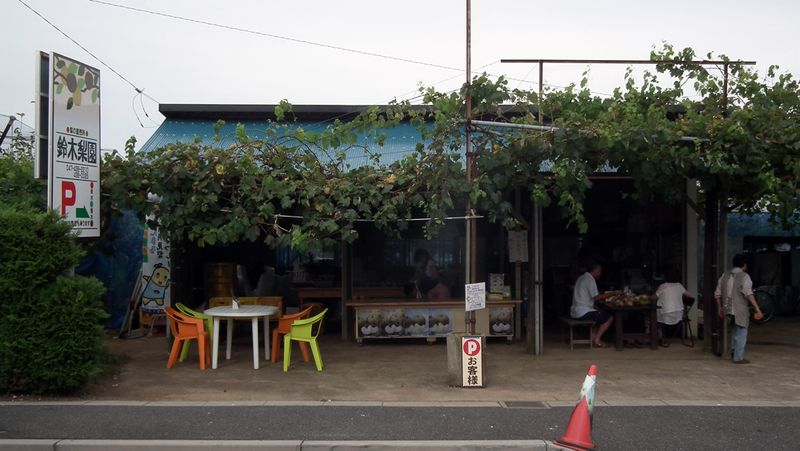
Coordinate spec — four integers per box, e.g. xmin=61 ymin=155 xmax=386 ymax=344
xmin=0 ymin=404 xmax=800 ymax=450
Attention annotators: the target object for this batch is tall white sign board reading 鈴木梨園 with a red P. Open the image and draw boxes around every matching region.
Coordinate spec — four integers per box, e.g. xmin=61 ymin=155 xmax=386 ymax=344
xmin=47 ymin=53 xmax=100 ymax=238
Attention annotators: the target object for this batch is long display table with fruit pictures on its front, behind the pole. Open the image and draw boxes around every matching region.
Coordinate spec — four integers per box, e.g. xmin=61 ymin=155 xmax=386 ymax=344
xmin=347 ymin=299 xmax=521 ymax=344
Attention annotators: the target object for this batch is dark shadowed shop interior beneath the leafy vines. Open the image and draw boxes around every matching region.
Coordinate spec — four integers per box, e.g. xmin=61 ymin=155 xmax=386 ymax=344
xmin=173 ymin=178 xmax=684 ymax=340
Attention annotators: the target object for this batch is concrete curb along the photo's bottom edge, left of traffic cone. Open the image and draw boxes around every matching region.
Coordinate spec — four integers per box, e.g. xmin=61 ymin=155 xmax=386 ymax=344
xmin=0 ymin=439 xmax=564 ymax=451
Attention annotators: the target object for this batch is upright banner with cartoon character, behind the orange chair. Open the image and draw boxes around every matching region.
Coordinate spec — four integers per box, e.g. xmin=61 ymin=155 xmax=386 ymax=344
xmin=139 ymin=218 xmax=171 ymax=312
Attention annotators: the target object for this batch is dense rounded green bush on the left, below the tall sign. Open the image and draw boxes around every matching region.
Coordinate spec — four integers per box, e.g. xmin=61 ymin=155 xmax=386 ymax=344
xmin=0 ymin=204 xmax=106 ymax=393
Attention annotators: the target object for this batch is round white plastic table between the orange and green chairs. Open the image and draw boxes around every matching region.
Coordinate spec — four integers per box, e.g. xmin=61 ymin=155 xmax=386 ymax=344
xmin=204 ymin=305 xmax=278 ymax=369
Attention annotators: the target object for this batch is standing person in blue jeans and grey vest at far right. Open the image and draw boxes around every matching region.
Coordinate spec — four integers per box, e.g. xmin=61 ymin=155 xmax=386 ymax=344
xmin=714 ymin=254 xmax=764 ymax=364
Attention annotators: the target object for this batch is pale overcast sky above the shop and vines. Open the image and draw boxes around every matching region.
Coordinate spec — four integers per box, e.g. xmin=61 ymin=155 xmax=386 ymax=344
xmin=0 ymin=0 xmax=800 ymax=150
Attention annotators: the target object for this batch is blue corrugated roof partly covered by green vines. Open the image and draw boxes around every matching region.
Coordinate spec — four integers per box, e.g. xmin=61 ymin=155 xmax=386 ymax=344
xmin=141 ymin=118 xmax=421 ymax=167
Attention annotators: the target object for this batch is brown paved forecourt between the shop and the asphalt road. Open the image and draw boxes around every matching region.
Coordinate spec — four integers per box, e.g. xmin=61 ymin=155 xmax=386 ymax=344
xmin=0 ymin=317 xmax=800 ymax=406
